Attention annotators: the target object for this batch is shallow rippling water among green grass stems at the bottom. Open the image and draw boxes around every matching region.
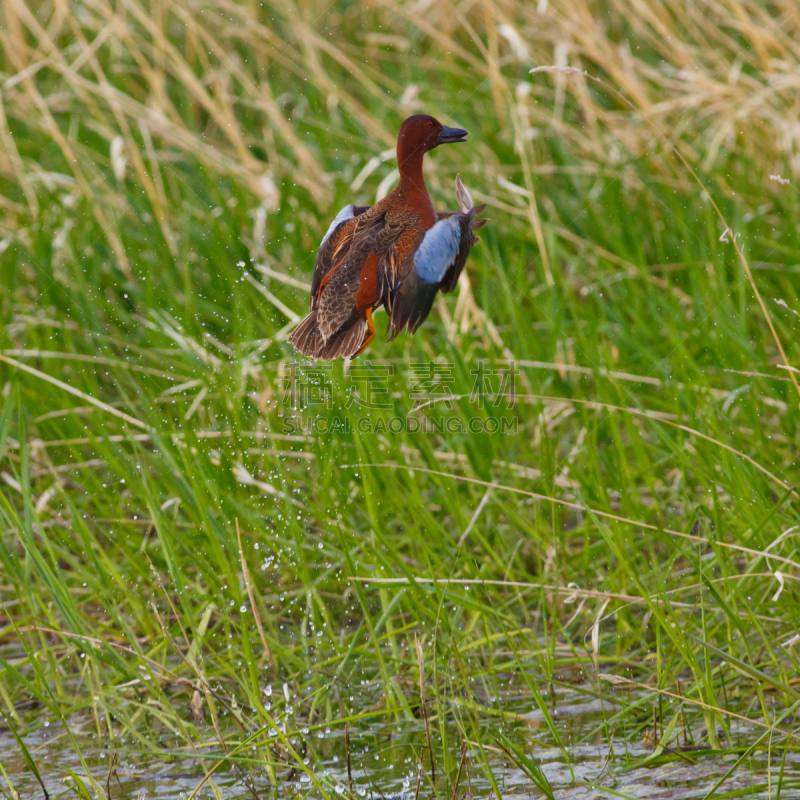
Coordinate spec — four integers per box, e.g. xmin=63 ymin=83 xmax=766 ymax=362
xmin=0 ymin=684 xmax=800 ymax=800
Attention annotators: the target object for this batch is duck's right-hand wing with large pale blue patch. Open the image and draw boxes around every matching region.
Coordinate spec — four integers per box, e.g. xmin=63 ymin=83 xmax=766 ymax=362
xmin=389 ymin=176 xmax=486 ymax=339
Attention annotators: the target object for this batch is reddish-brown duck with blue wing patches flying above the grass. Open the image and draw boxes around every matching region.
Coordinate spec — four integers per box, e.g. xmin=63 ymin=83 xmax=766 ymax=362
xmin=289 ymin=114 xmax=486 ymax=360
